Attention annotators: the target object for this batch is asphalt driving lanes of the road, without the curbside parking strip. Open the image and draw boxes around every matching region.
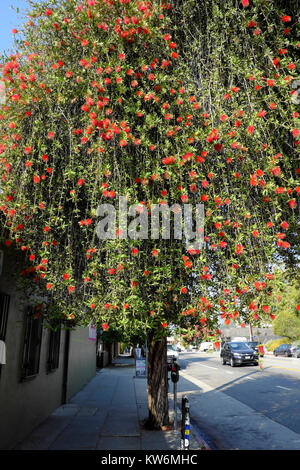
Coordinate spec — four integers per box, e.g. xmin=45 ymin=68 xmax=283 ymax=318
xmin=180 ymin=352 xmax=300 ymax=449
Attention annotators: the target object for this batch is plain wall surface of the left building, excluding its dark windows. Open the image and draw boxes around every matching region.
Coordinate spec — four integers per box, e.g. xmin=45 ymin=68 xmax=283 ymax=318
xmin=0 ymin=246 xmax=96 ymax=449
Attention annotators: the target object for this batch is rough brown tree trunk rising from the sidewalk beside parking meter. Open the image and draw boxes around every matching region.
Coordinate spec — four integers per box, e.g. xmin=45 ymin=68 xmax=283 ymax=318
xmin=145 ymin=339 xmax=169 ymax=429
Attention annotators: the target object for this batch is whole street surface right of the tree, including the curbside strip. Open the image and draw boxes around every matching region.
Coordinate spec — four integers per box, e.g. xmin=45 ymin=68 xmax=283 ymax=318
xmin=179 ymin=352 xmax=300 ymax=449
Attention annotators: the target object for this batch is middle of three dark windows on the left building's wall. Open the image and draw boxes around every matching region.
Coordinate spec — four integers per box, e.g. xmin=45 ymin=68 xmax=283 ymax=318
xmin=21 ymin=307 xmax=43 ymax=380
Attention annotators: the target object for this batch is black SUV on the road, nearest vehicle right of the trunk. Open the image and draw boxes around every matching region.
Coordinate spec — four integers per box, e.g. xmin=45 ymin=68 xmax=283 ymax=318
xmin=220 ymin=341 xmax=258 ymax=367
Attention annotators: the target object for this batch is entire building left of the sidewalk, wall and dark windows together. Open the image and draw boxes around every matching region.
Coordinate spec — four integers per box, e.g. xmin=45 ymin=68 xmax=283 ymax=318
xmin=0 ymin=245 xmax=96 ymax=450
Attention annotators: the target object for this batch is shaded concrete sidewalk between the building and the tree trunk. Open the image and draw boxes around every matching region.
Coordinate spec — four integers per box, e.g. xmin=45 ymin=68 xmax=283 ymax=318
xmin=15 ymin=357 xmax=202 ymax=450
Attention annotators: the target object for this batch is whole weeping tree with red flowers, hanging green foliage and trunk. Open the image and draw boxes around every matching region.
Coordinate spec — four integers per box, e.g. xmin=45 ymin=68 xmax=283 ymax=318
xmin=0 ymin=0 xmax=299 ymax=427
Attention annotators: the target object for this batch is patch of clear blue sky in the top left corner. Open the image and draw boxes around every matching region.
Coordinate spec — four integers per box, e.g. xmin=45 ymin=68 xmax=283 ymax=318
xmin=0 ymin=0 xmax=34 ymax=54
